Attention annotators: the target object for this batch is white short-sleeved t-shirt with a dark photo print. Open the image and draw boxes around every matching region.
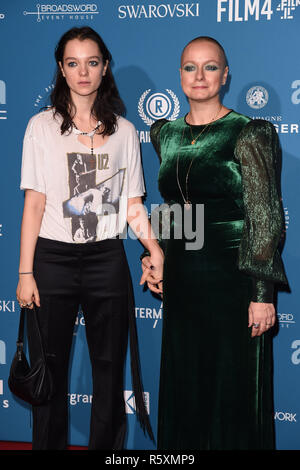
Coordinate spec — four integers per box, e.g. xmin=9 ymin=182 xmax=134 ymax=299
xmin=21 ymin=110 xmax=145 ymax=243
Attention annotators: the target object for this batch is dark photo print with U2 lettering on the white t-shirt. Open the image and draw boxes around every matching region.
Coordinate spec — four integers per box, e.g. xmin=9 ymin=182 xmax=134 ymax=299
xmin=63 ymin=153 xmax=125 ymax=243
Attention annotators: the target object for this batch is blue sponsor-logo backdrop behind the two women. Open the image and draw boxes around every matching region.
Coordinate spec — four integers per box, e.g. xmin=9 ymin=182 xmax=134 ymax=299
xmin=0 ymin=0 xmax=300 ymax=450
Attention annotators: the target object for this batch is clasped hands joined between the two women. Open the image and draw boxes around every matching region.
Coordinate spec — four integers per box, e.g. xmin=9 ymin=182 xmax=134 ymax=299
xmin=140 ymin=249 xmax=164 ymax=297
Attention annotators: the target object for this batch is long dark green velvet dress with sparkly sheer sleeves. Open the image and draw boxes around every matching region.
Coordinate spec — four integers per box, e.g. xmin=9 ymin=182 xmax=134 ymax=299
xmin=151 ymin=111 xmax=287 ymax=450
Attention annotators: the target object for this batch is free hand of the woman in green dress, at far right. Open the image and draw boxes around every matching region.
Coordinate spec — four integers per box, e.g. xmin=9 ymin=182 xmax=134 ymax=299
xmin=248 ymin=302 xmax=276 ymax=337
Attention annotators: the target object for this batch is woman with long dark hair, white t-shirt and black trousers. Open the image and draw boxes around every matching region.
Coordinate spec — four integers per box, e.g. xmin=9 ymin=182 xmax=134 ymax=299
xmin=17 ymin=27 xmax=163 ymax=450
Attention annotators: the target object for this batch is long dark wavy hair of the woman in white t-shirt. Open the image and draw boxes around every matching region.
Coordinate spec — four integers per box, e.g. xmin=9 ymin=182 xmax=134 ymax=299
xmin=50 ymin=26 xmax=125 ymax=135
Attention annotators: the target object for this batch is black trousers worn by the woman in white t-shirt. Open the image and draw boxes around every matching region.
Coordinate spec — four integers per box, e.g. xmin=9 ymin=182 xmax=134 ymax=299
xmin=28 ymin=238 xmax=130 ymax=450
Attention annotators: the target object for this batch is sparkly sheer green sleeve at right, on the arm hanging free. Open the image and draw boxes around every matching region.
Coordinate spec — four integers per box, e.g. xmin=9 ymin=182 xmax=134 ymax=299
xmin=235 ymin=120 xmax=287 ymax=302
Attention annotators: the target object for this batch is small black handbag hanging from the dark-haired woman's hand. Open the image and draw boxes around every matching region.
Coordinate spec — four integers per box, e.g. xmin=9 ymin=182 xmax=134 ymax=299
xmin=8 ymin=306 xmax=53 ymax=405
